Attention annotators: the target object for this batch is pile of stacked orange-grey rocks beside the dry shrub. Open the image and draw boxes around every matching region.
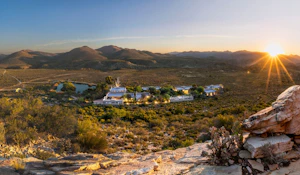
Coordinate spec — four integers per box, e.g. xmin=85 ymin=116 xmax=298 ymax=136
xmin=243 ymin=85 xmax=300 ymax=173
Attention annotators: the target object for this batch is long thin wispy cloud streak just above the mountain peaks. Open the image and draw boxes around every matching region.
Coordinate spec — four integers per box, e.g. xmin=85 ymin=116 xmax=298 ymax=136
xmin=37 ymin=35 xmax=232 ymax=47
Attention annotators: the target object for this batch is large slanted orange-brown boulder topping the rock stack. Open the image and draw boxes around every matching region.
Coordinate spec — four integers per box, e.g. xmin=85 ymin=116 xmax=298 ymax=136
xmin=243 ymin=85 xmax=300 ymax=135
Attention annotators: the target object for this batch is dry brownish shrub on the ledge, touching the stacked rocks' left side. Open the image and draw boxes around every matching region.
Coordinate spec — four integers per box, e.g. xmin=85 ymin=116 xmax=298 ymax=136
xmin=208 ymin=127 xmax=242 ymax=165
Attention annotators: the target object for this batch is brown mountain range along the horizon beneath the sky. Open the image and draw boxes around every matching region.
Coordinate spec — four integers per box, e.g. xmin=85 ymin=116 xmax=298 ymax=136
xmin=0 ymin=45 xmax=300 ymax=71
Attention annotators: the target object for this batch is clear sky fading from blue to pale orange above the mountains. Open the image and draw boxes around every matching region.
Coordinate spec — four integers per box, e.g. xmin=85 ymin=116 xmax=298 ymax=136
xmin=0 ymin=0 xmax=300 ymax=55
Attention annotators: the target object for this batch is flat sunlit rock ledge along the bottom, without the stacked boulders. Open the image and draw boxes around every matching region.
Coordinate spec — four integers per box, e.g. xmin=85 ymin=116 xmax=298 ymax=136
xmin=0 ymin=142 xmax=300 ymax=175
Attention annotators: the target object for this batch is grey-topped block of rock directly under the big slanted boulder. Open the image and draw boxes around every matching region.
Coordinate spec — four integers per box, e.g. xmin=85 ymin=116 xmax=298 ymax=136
xmin=244 ymin=135 xmax=294 ymax=158
